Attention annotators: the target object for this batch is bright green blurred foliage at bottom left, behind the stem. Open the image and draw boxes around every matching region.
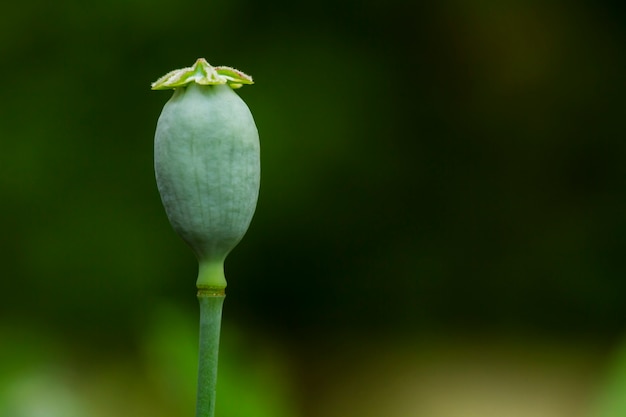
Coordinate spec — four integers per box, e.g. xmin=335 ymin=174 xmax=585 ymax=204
xmin=0 ymin=303 xmax=296 ymax=417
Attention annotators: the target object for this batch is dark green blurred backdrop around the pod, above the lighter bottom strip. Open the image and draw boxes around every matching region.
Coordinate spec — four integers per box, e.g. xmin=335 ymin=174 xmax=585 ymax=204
xmin=0 ymin=0 xmax=626 ymax=414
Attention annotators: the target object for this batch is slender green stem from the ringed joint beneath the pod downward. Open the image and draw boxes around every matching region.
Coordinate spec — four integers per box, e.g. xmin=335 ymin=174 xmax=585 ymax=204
xmin=196 ymin=287 xmax=226 ymax=417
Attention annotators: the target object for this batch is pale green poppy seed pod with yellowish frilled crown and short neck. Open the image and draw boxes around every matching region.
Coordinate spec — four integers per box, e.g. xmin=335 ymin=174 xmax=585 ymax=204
xmin=152 ymin=59 xmax=260 ymax=289
